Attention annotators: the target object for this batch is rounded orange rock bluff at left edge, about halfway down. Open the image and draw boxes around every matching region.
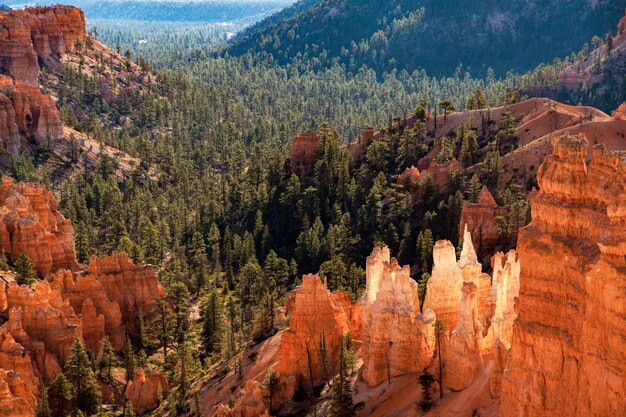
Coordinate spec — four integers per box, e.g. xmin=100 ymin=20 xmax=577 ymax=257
xmin=0 ymin=177 xmax=78 ymax=275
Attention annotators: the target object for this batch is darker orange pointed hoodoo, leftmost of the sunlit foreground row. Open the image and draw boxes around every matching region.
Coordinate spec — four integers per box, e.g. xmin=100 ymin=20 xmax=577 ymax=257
xmin=275 ymin=275 xmax=350 ymax=386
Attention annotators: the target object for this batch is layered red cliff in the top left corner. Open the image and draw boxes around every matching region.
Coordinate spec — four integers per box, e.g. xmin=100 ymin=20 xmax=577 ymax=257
xmin=0 ymin=6 xmax=86 ymax=155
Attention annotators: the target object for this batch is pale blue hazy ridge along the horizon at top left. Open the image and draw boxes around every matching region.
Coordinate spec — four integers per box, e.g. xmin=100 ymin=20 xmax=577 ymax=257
xmin=8 ymin=0 xmax=293 ymax=22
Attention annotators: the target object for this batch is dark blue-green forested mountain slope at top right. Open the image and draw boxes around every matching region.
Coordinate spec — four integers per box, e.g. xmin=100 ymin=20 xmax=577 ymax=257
xmin=227 ymin=0 xmax=626 ymax=75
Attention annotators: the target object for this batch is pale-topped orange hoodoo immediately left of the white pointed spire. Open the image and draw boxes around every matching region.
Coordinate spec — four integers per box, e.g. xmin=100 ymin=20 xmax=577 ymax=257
xmin=361 ymin=248 xmax=435 ymax=387
